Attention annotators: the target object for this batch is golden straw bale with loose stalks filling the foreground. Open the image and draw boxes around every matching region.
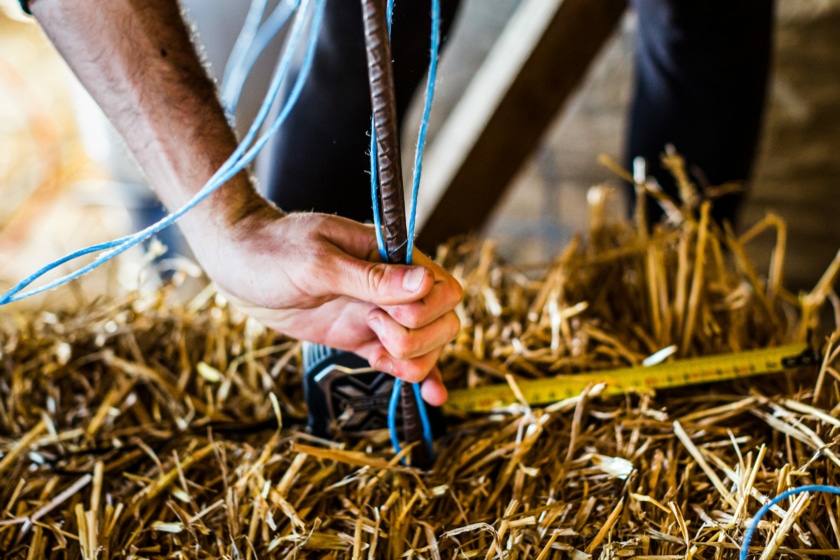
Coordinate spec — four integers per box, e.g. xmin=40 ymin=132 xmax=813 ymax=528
xmin=0 ymin=161 xmax=840 ymax=560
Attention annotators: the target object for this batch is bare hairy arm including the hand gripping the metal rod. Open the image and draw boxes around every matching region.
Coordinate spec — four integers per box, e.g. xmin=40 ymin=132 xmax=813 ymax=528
xmin=30 ymin=0 xmax=461 ymax=404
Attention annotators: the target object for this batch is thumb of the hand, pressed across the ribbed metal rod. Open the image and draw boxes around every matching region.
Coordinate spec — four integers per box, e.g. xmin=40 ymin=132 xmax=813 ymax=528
xmin=339 ymin=257 xmax=435 ymax=306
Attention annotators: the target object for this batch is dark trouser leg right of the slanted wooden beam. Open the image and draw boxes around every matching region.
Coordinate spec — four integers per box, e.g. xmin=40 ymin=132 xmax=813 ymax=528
xmin=626 ymin=0 xmax=773 ymax=228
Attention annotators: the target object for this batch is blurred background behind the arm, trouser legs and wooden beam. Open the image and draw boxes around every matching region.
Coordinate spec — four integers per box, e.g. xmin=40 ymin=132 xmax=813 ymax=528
xmin=0 ymin=0 xmax=840 ymax=310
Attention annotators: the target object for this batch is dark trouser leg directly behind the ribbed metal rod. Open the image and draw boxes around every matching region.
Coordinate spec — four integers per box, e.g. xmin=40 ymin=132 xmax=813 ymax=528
xmin=266 ymin=0 xmax=460 ymax=221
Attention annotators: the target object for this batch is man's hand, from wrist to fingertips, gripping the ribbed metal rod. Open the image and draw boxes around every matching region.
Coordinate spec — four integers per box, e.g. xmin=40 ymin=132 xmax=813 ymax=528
xmin=191 ymin=205 xmax=462 ymax=405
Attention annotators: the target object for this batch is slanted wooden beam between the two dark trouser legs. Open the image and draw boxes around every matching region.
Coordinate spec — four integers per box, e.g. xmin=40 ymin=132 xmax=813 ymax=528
xmin=418 ymin=0 xmax=627 ymax=250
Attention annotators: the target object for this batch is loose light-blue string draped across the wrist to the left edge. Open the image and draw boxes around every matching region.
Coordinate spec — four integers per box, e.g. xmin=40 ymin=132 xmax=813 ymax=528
xmin=0 ymin=0 xmax=326 ymax=305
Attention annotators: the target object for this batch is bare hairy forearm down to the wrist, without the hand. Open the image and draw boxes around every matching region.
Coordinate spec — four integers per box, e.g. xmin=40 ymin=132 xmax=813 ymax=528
xmin=30 ymin=0 xmax=266 ymax=235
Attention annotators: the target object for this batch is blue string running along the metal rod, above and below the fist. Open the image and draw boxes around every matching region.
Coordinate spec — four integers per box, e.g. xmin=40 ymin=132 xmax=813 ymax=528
xmin=378 ymin=0 xmax=441 ymax=464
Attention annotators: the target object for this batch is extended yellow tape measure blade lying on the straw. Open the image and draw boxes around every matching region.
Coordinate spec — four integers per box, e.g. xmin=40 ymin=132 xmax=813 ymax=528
xmin=444 ymin=343 xmax=819 ymax=412
